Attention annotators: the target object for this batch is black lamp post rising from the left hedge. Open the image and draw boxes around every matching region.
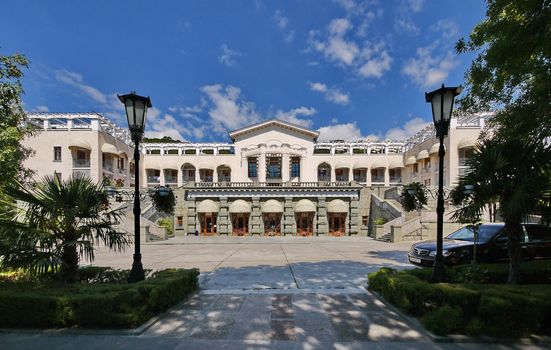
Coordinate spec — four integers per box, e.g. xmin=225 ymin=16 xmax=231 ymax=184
xmin=118 ymin=91 xmax=152 ymax=283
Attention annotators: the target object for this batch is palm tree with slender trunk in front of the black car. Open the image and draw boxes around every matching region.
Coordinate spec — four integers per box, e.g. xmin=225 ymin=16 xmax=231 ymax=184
xmin=451 ymin=138 xmax=551 ymax=283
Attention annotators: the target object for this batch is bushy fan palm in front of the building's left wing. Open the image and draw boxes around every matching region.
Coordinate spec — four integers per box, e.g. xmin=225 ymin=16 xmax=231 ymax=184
xmin=0 ymin=177 xmax=128 ymax=282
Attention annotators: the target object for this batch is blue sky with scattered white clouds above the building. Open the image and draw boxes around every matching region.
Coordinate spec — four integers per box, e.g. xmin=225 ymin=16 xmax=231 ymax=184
xmin=0 ymin=0 xmax=485 ymax=142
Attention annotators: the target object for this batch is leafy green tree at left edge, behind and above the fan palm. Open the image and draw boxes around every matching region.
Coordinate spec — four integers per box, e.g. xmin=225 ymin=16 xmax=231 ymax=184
xmin=0 ymin=54 xmax=31 ymax=204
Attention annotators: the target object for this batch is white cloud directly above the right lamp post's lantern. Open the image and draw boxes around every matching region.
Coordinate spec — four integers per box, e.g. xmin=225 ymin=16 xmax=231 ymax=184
xmin=402 ymin=45 xmax=459 ymax=89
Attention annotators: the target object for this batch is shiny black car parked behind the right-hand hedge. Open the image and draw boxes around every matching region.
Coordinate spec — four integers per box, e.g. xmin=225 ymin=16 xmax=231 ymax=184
xmin=408 ymin=223 xmax=551 ymax=266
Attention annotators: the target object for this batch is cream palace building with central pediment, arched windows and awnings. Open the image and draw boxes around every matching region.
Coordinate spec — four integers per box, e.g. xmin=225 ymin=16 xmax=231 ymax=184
xmin=25 ymin=113 xmax=490 ymax=241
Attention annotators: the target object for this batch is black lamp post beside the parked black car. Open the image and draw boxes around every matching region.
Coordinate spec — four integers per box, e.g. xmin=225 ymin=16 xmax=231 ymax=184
xmin=425 ymin=84 xmax=462 ymax=282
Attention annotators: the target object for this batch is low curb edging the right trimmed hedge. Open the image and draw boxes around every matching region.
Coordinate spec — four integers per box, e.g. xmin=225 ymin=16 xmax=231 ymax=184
xmin=366 ymin=287 xmax=551 ymax=345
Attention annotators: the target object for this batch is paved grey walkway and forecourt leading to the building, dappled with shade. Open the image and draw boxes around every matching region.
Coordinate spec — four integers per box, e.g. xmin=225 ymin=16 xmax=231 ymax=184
xmin=0 ymin=237 xmax=537 ymax=350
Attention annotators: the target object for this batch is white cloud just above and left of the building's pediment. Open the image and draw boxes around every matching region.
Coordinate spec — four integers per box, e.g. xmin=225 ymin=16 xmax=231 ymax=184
xmin=201 ymin=84 xmax=261 ymax=134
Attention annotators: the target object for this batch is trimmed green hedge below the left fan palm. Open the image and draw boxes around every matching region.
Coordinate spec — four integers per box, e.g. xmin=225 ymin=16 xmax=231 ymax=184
xmin=0 ymin=269 xmax=199 ymax=328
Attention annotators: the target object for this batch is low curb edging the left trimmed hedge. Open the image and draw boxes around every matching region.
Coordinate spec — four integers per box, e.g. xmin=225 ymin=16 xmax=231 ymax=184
xmin=0 ymin=288 xmax=200 ymax=336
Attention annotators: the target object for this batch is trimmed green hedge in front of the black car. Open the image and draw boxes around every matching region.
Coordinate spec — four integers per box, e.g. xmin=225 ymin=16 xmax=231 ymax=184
xmin=369 ymin=268 xmax=551 ymax=338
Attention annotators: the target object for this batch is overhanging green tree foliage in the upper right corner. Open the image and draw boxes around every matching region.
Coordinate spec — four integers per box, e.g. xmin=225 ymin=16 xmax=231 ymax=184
xmin=456 ymin=0 xmax=551 ymax=146
